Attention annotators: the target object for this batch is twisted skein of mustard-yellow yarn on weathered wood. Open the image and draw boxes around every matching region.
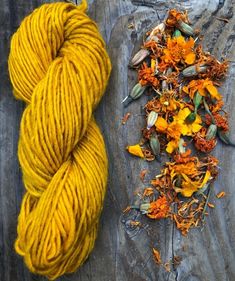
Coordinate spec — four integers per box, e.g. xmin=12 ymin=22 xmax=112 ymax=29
xmin=9 ymin=1 xmax=111 ymax=279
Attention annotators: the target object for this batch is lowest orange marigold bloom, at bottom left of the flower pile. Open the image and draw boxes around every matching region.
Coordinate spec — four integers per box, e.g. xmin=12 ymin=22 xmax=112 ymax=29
xmin=147 ymin=195 xmax=170 ymax=219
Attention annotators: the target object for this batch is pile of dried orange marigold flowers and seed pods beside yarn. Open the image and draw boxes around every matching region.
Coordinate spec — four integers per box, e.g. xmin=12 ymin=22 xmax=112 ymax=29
xmin=123 ymin=10 xmax=232 ymax=256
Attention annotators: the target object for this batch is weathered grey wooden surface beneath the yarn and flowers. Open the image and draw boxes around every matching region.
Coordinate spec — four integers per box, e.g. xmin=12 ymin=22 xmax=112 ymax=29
xmin=0 ymin=0 xmax=235 ymax=281
